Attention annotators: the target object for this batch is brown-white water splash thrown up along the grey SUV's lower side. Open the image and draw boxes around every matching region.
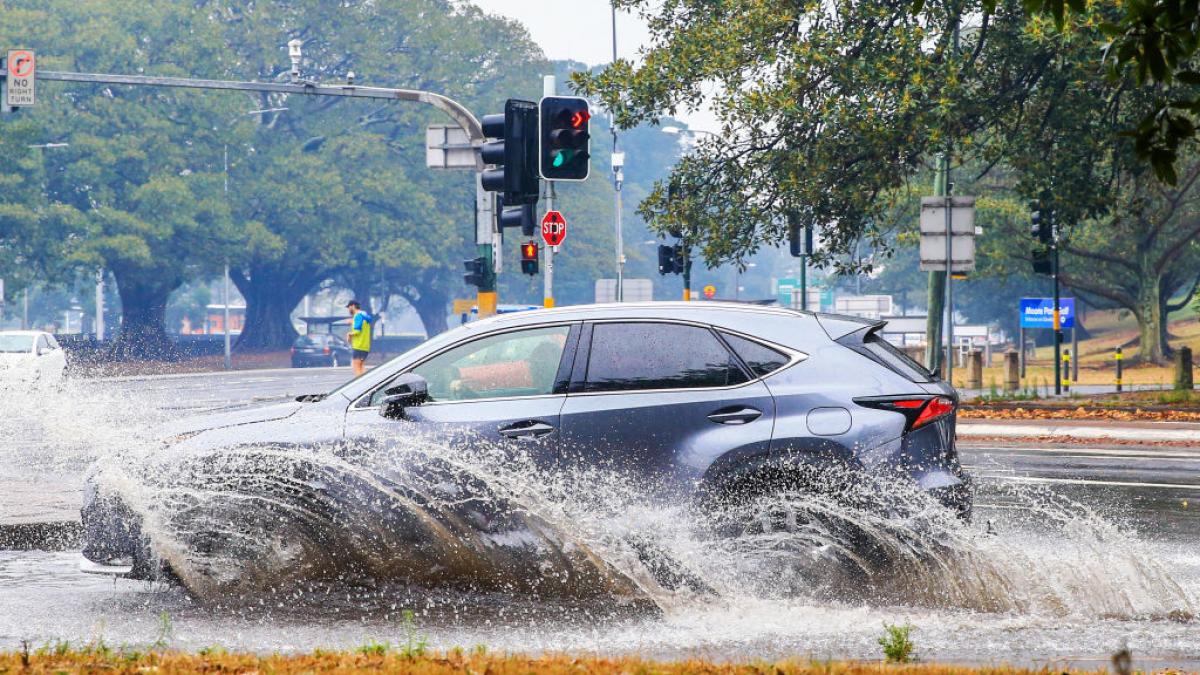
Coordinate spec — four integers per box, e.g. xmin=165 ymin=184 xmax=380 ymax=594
xmin=88 ymin=425 xmax=1195 ymax=620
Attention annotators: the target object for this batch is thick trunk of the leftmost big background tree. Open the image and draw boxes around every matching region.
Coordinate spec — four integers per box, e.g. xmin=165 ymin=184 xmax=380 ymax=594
xmin=110 ymin=268 xmax=181 ymax=360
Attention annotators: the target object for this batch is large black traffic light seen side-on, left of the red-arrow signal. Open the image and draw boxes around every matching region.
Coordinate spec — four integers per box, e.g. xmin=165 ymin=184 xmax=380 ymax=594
xmin=480 ymin=98 xmax=538 ymax=205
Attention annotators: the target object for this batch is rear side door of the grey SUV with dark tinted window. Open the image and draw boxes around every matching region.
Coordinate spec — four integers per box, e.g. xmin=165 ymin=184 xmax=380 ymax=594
xmin=560 ymin=321 xmax=775 ymax=485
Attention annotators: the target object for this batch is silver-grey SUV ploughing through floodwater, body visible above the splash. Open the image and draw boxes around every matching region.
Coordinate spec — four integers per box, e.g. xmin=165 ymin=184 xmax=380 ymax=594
xmin=84 ymin=303 xmax=971 ymax=575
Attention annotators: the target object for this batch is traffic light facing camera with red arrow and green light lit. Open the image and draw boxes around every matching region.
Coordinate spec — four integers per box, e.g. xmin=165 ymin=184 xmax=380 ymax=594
xmin=538 ymin=96 xmax=592 ymax=180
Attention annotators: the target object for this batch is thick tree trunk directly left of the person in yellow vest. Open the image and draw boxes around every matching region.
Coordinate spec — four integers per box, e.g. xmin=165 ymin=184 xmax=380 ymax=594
xmin=232 ymin=268 xmax=317 ymax=353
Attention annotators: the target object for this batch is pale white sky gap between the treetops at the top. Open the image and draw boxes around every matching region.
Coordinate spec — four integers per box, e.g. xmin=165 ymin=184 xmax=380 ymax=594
xmin=472 ymin=0 xmax=719 ymax=131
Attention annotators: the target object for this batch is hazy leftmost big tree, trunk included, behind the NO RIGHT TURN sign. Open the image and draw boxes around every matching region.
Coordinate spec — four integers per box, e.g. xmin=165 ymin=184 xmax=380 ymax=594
xmin=0 ymin=0 xmax=243 ymax=356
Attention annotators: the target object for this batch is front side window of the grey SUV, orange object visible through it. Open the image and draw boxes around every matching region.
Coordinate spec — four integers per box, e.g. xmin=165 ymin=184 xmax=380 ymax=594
xmin=371 ymin=325 xmax=571 ymax=406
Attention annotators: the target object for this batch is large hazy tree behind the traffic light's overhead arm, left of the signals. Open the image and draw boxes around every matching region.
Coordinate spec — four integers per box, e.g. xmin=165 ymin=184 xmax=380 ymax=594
xmin=199 ymin=0 xmax=546 ymax=350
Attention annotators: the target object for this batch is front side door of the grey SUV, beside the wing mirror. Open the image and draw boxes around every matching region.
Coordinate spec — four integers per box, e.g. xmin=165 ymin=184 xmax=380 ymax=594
xmin=346 ymin=323 xmax=580 ymax=459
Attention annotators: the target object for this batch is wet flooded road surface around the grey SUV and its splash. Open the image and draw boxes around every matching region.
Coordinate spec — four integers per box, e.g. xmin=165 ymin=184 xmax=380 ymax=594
xmin=0 ymin=369 xmax=1200 ymax=669
